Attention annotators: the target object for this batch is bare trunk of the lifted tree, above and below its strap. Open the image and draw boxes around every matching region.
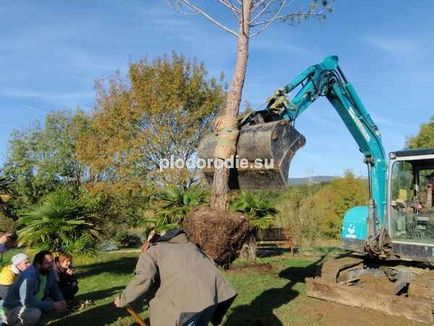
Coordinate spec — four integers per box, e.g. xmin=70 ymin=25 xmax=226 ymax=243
xmin=210 ymin=0 xmax=252 ymax=209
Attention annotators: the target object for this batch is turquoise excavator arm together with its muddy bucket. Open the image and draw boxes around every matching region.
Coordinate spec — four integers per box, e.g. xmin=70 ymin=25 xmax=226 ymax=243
xmin=199 ymin=56 xmax=386 ymax=239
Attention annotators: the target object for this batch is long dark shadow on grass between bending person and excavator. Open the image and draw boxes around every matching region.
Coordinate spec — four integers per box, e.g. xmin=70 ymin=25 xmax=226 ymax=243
xmin=225 ymin=253 xmax=327 ymax=326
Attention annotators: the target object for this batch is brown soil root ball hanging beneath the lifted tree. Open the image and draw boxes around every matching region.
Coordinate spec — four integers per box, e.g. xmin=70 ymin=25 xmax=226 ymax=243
xmin=183 ymin=206 xmax=249 ymax=266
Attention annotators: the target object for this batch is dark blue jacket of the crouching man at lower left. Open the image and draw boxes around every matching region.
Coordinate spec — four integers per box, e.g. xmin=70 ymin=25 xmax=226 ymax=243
xmin=3 ymin=266 xmax=63 ymax=312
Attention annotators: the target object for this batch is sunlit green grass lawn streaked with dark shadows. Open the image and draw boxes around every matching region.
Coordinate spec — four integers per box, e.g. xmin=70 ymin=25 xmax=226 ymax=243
xmin=0 ymin=250 xmax=338 ymax=326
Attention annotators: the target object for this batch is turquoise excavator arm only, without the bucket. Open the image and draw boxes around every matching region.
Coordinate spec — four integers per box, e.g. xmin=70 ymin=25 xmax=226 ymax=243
xmin=267 ymin=56 xmax=387 ymax=229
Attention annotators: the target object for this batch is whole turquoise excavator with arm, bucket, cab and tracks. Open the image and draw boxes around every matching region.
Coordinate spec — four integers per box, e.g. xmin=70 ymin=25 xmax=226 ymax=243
xmin=198 ymin=56 xmax=434 ymax=323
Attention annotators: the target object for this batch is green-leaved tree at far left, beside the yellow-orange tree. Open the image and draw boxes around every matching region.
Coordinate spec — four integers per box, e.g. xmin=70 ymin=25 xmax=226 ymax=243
xmin=3 ymin=110 xmax=85 ymax=208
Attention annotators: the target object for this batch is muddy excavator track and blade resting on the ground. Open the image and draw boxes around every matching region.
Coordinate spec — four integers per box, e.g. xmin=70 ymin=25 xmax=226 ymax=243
xmin=306 ymin=256 xmax=434 ymax=323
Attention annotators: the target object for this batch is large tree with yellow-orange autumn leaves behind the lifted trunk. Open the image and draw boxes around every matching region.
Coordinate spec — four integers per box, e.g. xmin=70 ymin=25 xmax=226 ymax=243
xmin=78 ymin=53 xmax=224 ymax=187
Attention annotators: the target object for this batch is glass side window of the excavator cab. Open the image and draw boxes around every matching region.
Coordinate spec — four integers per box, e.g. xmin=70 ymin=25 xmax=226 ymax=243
xmin=390 ymin=160 xmax=434 ymax=243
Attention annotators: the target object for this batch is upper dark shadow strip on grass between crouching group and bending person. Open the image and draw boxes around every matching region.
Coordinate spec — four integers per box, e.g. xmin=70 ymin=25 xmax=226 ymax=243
xmin=77 ymin=257 xmax=137 ymax=278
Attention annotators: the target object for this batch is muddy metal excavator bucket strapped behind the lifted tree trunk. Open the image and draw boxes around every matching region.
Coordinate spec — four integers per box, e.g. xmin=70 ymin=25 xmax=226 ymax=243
xmin=199 ymin=120 xmax=306 ymax=189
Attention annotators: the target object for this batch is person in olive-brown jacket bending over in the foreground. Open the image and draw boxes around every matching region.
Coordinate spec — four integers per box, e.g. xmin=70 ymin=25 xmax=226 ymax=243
xmin=115 ymin=229 xmax=236 ymax=326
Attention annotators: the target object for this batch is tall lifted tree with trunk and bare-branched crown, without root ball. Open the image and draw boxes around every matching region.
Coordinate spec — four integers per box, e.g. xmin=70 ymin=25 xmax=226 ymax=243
xmin=170 ymin=0 xmax=331 ymax=209
